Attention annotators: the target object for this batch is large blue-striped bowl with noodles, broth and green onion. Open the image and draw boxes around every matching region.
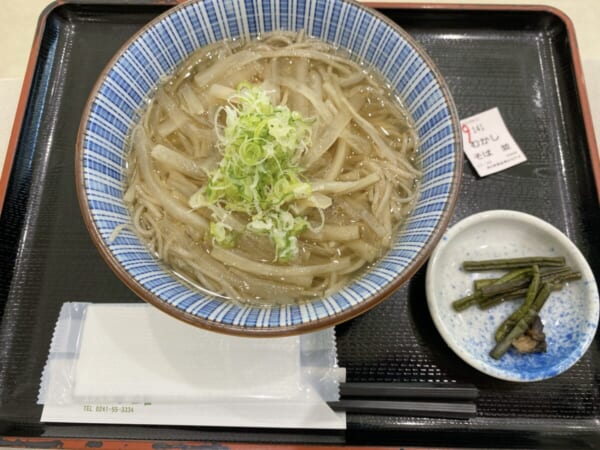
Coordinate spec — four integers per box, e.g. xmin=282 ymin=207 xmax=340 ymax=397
xmin=76 ymin=0 xmax=462 ymax=336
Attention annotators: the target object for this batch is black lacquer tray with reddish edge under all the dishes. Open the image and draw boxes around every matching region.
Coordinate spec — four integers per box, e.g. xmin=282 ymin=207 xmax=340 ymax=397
xmin=0 ymin=1 xmax=600 ymax=448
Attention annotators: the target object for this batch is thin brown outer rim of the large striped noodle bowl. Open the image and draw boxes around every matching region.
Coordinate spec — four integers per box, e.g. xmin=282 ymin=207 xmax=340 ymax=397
xmin=75 ymin=0 xmax=463 ymax=337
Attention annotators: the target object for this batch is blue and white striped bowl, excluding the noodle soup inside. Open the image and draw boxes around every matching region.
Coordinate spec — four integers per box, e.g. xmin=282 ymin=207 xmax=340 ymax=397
xmin=77 ymin=0 xmax=462 ymax=335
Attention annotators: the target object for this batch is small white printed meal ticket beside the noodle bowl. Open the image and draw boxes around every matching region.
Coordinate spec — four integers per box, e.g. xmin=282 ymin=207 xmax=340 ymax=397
xmin=460 ymin=108 xmax=527 ymax=177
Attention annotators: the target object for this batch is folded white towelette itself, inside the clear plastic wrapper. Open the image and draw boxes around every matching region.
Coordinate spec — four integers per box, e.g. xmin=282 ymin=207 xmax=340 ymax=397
xmin=73 ymin=305 xmax=301 ymax=403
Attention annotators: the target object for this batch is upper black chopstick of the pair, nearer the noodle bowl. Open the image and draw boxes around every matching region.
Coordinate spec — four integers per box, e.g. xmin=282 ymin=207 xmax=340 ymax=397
xmin=340 ymin=382 xmax=479 ymax=400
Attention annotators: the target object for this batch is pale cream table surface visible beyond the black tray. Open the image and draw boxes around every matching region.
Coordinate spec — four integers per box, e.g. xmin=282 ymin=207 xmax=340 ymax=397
xmin=0 ymin=0 xmax=600 ymax=178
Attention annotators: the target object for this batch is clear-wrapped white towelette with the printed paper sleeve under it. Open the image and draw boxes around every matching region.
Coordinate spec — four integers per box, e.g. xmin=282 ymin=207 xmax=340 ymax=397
xmin=38 ymin=303 xmax=345 ymax=429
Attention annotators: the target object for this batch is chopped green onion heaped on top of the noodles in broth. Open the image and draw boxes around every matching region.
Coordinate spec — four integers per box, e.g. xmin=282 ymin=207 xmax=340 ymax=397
xmin=189 ymin=83 xmax=312 ymax=261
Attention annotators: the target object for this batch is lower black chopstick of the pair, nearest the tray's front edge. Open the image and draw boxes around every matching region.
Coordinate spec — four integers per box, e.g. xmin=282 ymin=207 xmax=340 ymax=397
xmin=328 ymin=399 xmax=477 ymax=419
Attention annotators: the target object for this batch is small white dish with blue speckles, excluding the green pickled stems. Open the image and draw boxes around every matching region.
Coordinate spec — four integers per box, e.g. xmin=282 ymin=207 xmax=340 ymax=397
xmin=426 ymin=210 xmax=599 ymax=381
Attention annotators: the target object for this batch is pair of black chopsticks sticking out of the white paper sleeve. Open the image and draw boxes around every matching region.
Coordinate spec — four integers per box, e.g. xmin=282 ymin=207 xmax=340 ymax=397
xmin=328 ymin=383 xmax=478 ymax=419
